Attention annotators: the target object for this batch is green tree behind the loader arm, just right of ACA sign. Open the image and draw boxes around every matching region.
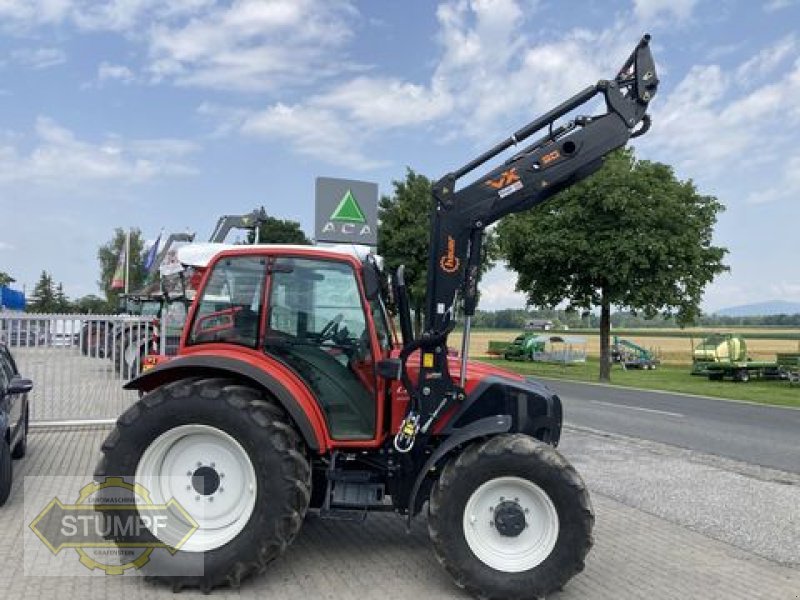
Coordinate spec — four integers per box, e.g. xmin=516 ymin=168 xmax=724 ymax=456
xmin=378 ymin=168 xmax=496 ymax=335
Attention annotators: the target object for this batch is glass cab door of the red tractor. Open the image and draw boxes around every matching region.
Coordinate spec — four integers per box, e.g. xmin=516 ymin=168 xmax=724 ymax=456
xmin=264 ymin=257 xmax=383 ymax=441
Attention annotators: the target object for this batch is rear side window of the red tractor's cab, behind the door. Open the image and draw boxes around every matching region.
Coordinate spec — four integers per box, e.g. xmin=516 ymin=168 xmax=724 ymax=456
xmin=189 ymin=256 xmax=266 ymax=347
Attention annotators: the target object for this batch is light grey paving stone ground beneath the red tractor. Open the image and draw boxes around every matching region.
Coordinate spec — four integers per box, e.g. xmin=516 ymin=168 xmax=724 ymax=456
xmin=0 ymin=429 xmax=800 ymax=600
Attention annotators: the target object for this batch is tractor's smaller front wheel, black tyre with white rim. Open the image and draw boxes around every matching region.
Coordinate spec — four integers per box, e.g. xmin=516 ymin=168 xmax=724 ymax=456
xmin=428 ymin=434 xmax=594 ymax=600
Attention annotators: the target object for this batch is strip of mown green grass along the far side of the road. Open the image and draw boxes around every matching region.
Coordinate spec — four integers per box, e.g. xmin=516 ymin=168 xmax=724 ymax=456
xmin=479 ymin=358 xmax=800 ymax=407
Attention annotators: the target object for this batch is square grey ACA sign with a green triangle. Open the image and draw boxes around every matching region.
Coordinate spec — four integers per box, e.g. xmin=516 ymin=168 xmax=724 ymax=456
xmin=315 ymin=177 xmax=378 ymax=246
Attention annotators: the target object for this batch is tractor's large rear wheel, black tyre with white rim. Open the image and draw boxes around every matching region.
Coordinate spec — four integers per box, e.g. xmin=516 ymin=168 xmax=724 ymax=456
xmin=95 ymin=378 xmax=311 ymax=593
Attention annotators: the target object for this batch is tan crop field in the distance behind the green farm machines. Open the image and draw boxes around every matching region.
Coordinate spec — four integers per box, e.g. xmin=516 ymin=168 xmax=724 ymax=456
xmin=450 ymin=328 xmax=800 ymax=365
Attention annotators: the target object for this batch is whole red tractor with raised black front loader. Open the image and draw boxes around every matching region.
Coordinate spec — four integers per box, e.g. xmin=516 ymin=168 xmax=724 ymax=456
xmin=95 ymin=36 xmax=658 ymax=598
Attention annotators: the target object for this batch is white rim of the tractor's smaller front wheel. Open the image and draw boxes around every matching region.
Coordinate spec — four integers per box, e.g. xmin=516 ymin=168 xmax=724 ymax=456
xmin=463 ymin=477 xmax=559 ymax=573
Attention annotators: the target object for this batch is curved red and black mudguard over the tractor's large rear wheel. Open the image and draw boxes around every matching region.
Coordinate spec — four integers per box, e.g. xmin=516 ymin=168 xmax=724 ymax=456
xmin=123 ymin=355 xmax=326 ymax=452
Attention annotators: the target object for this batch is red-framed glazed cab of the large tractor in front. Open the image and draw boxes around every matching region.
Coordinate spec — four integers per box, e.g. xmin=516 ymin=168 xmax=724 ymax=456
xmin=181 ymin=245 xmax=393 ymax=441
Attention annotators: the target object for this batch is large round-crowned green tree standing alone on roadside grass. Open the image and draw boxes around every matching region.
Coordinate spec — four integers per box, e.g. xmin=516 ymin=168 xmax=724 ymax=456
xmin=498 ymin=149 xmax=727 ymax=381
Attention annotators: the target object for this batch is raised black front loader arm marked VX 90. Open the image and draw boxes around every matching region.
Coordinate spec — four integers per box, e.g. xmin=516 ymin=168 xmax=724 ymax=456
xmin=390 ymin=35 xmax=658 ymax=448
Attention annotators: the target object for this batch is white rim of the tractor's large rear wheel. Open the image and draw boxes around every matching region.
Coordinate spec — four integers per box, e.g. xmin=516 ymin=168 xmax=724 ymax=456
xmin=135 ymin=424 xmax=258 ymax=552
